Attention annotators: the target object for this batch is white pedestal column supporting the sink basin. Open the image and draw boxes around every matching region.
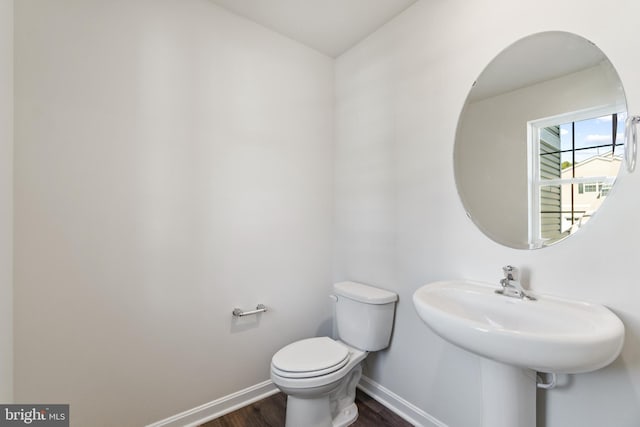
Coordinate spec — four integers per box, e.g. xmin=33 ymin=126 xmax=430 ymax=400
xmin=481 ymin=358 xmax=537 ymax=427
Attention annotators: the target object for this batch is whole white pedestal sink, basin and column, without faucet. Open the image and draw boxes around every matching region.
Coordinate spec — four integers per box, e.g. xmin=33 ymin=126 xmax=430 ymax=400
xmin=413 ymin=280 xmax=624 ymax=427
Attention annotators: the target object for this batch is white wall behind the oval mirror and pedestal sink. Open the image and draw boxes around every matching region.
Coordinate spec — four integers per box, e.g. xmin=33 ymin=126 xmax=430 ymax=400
xmin=334 ymin=0 xmax=640 ymax=427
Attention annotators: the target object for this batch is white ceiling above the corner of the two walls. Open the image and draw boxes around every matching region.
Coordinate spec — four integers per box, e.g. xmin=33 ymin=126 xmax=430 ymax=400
xmin=211 ymin=0 xmax=418 ymax=58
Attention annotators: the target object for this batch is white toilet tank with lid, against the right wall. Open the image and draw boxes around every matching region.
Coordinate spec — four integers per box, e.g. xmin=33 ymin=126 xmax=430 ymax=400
xmin=333 ymin=282 xmax=398 ymax=351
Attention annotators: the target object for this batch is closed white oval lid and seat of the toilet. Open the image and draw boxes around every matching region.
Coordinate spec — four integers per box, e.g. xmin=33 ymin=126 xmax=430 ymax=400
xmin=271 ymin=337 xmax=350 ymax=378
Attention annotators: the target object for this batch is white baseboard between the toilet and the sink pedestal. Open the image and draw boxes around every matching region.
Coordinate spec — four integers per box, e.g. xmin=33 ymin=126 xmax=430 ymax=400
xmin=358 ymin=375 xmax=447 ymax=427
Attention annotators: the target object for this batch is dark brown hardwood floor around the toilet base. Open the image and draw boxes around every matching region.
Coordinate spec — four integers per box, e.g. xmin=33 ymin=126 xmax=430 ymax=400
xmin=201 ymin=390 xmax=411 ymax=427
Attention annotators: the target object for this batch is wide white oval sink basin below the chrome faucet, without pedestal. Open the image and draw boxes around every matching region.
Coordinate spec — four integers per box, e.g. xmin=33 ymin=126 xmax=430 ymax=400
xmin=413 ymin=280 xmax=624 ymax=373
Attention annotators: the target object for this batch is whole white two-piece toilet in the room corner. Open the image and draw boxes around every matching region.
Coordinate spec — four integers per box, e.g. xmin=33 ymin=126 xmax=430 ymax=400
xmin=271 ymin=282 xmax=398 ymax=427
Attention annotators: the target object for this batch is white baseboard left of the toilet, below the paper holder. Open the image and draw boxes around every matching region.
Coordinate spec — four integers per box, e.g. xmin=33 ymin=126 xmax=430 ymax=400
xmin=147 ymin=380 xmax=280 ymax=427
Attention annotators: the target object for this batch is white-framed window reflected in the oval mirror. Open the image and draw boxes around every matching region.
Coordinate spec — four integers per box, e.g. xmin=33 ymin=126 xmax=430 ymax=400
xmin=529 ymin=109 xmax=626 ymax=247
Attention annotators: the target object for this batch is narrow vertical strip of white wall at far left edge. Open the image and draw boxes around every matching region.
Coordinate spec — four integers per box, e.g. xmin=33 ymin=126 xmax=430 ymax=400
xmin=0 ymin=0 xmax=13 ymax=403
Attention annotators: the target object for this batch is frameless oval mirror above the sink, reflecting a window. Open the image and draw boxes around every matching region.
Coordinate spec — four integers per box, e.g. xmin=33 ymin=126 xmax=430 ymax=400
xmin=454 ymin=31 xmax=627 ymax=249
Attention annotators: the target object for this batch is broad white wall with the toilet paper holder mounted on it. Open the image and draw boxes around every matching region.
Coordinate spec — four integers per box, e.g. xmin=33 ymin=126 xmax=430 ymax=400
xmin=13 ymin=0 xmax=333 ymax=426
